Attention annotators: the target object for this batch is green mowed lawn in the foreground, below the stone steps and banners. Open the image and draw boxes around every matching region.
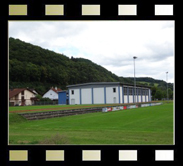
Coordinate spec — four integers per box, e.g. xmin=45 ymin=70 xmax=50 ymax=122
xmin=9 ymin=103 xmax=173 ymax=145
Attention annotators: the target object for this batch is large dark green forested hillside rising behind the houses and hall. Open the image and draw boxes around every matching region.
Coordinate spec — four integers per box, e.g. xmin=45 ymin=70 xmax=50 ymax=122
xmin=9 ymin=38 xmax=132 ymax=94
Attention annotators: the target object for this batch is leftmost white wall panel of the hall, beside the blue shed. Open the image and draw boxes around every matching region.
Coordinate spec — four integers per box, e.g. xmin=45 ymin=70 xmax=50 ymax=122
xmin=69 ymin=89 xmax=80 ymax=105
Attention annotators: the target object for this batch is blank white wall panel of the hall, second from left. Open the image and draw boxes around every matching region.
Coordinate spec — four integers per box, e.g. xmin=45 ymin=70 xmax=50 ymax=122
xmin=81 ymin=88 xmax=92 ymax=104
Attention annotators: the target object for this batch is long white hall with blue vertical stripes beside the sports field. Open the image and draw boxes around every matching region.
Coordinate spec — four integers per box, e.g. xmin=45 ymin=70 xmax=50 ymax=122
xmin=67 ymin=82 xmax=151 ymax=104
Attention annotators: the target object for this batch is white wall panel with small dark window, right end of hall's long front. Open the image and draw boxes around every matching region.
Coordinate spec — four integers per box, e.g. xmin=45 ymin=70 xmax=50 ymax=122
xmin=106 ymin=86 xmax=119 ymax=104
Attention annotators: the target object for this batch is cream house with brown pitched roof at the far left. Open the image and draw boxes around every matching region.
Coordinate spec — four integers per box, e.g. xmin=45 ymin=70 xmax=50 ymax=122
xmin=9 ymin=88 xmax=37 ymax=106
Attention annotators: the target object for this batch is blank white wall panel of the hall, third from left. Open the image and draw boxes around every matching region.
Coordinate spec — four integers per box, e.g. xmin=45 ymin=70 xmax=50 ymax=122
xmin=93 ymin=87 xmax=104 ymax=104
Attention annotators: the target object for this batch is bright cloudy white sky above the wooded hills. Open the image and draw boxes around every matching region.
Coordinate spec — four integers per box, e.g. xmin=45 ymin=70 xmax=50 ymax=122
xmin=9 ymin=21 xmax=175 ymax=83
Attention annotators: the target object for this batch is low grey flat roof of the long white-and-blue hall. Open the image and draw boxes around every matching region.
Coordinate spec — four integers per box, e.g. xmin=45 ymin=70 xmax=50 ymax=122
xmin=67 ymin=82 xmax=150 ymax=88
